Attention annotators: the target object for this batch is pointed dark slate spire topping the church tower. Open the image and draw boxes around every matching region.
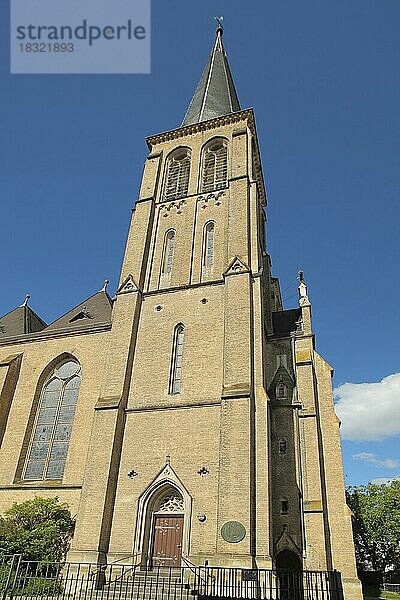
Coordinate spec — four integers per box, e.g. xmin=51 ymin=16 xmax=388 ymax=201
xmin=182 ymin=27 xmax=240 ymax=127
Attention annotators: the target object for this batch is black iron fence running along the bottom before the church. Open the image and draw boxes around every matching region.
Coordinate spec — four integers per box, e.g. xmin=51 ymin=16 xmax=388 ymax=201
xmin=0 ymin=555 xmax=343 ymax=600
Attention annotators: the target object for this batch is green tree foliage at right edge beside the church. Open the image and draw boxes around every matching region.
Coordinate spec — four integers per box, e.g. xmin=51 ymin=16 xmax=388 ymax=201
xmin=346 ymin=480 xmax=400 ymax=574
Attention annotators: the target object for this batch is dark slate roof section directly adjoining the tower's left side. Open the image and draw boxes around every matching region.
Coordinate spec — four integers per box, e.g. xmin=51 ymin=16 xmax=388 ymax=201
xmin=46 ymin=290 xmax=112 ymax=333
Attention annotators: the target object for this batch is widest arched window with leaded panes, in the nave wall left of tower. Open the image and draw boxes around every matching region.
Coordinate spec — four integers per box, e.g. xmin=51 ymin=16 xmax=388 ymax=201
xmin=23 ymin=360 xmax=81 ymax=481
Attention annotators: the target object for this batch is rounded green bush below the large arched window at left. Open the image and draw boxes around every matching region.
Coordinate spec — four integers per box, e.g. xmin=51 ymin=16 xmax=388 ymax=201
xmin=0 ymin=498 xmax=74 ymax=562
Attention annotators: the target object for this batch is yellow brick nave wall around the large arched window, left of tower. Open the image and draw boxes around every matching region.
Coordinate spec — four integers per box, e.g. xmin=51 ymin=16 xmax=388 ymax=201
xmin=0 ymin=332 xmax=109 ymax=514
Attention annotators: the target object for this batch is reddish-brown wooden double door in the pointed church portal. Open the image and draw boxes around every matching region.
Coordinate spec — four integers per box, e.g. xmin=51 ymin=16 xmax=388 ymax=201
xmin=151 ymin=514 xmax=183 ymax=567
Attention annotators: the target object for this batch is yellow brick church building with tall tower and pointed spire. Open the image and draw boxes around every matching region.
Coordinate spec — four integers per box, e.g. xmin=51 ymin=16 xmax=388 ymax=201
xmin=0 ymin=27 xmax=362 ymax=600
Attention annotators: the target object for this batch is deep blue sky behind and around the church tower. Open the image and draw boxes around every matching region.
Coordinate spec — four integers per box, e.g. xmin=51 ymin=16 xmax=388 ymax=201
xmin=0 ymin=0 xmax=400 ymax=484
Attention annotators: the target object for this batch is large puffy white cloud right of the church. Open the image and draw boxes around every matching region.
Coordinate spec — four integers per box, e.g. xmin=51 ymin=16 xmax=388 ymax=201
xmin=334 ymin=373 xmax=400 ymax=441
